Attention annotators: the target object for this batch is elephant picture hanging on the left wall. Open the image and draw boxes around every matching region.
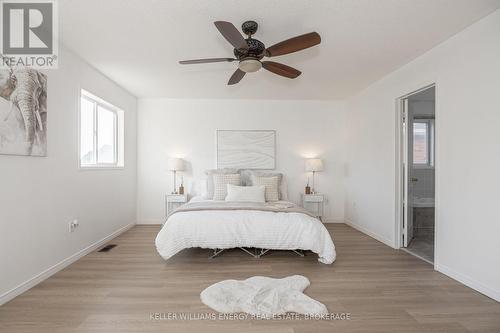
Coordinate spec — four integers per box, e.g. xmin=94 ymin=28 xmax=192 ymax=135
xmin=0 ymin=68 xmax=47 ymax=156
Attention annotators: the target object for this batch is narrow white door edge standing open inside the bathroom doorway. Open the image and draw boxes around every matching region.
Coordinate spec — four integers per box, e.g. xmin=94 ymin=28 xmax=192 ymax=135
xmin=403 ymin=98 xmax=414 ymax=247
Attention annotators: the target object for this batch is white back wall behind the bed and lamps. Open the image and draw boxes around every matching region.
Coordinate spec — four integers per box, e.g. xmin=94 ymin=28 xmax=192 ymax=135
xmin=137 ymin=99 xmax=345 ymax=223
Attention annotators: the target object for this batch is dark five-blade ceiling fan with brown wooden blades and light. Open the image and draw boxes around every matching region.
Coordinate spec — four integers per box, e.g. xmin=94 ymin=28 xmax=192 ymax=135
xmin=179 ymin=21 xmax=321 ymax=85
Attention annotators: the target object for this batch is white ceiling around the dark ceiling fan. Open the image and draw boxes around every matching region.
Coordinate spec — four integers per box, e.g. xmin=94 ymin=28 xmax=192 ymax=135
xmin=59 ymin=0 xmax=500 ymax=99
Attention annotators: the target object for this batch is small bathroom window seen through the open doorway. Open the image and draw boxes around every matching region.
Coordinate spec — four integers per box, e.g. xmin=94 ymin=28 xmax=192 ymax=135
xmin=413 ymin=119 xmax=434 ymax=167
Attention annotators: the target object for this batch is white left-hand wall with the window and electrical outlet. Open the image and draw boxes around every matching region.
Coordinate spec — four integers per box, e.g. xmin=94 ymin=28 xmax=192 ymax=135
xmin=0 ymin=47 xmax=137 ymax=304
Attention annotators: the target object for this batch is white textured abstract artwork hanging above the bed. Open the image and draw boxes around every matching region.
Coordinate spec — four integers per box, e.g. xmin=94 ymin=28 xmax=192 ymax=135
xmin=216 ymin=130 xmax=276 ymax=169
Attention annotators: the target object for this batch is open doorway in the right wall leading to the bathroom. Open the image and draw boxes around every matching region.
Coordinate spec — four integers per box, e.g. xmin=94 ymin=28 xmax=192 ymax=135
xmin=398 ymin=86 xmax=436 ymax=263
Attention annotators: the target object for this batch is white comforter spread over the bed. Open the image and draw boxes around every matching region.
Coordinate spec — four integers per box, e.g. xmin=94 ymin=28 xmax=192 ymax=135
xmin=155 ymin=198 xmax=336 ymax=264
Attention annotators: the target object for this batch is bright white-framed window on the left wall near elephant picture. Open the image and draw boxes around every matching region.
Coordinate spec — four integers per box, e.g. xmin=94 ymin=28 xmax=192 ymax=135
xmin=80 ymin=90 xmax=123 ymax=168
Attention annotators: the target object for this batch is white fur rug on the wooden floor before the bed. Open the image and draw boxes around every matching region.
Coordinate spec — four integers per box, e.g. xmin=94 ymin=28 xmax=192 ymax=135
xmin=200 ymin=275 xmax=328 ymax=316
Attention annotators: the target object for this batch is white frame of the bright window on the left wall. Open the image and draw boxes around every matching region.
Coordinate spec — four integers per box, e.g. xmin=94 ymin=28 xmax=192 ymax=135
xmin=78 ymin=89 xmax=124 ymax=170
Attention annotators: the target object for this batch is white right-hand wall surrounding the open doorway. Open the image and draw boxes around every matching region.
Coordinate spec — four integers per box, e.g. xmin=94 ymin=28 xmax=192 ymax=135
xmin=345 ymin=11 xmax=500 ymax=300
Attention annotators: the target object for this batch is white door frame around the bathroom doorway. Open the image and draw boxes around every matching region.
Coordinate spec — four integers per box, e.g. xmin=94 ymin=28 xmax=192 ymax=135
xmin=394 ymin=82 xmax=439 ymax=269
